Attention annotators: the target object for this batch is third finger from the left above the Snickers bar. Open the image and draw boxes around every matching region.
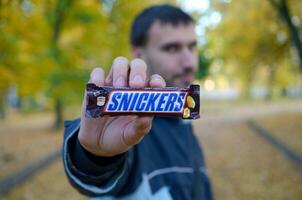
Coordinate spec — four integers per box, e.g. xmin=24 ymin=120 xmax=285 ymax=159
xmin=129 ymin=58 xmax=147 ymax=88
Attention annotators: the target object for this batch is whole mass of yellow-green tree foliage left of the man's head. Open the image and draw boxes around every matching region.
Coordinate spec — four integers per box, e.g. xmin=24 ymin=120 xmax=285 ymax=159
xmin=0 ymin=0 xmax=176 ymax=123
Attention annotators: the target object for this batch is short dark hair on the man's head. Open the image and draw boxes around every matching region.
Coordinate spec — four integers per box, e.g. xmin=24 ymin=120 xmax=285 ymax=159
xmin=130 ymin=4 xmax=194 ymax=47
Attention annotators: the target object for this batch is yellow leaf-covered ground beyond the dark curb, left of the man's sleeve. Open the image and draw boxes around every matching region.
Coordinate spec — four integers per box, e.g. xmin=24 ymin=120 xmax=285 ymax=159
xmin=0 ymin=113 xmax=63 ymax=179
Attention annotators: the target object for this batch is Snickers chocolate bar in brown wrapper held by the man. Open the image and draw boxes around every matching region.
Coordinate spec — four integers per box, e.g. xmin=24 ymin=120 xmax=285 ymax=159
xmin=85 ymin=83 xmax=199 ymax=119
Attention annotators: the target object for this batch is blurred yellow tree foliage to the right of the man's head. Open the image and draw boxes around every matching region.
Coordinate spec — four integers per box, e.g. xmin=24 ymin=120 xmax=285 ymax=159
xmin=208 ymin=0 xmax=295 ymax=96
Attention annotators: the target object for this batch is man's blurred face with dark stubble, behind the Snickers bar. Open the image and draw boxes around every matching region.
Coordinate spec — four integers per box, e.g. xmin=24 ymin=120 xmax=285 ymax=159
xmin=136 ymin=21 xmax=198 ymax=87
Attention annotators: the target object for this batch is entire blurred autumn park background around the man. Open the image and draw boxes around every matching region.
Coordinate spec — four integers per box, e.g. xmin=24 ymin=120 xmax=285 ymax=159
xmin=0 ymin=0 xmax=302 ymax=199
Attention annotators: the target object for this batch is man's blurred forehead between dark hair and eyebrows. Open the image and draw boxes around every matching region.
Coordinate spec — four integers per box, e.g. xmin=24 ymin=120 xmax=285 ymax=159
xmin=148 ymin=21 xmax=196 ymax=43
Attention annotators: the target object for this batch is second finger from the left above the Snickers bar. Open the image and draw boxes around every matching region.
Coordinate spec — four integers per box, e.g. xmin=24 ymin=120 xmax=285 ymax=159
xmin=111 ymin=57 xmax=129 ymax=87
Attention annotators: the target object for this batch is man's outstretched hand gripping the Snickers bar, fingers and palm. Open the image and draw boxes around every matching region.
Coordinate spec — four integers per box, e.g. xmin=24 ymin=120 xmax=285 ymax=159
xmin=78 ymin=57 xmax=166 ymax=157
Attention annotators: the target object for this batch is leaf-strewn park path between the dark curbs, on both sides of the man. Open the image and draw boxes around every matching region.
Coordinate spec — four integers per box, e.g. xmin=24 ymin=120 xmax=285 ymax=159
xmin=0 ymin=100 xmax=302 ymax=200
